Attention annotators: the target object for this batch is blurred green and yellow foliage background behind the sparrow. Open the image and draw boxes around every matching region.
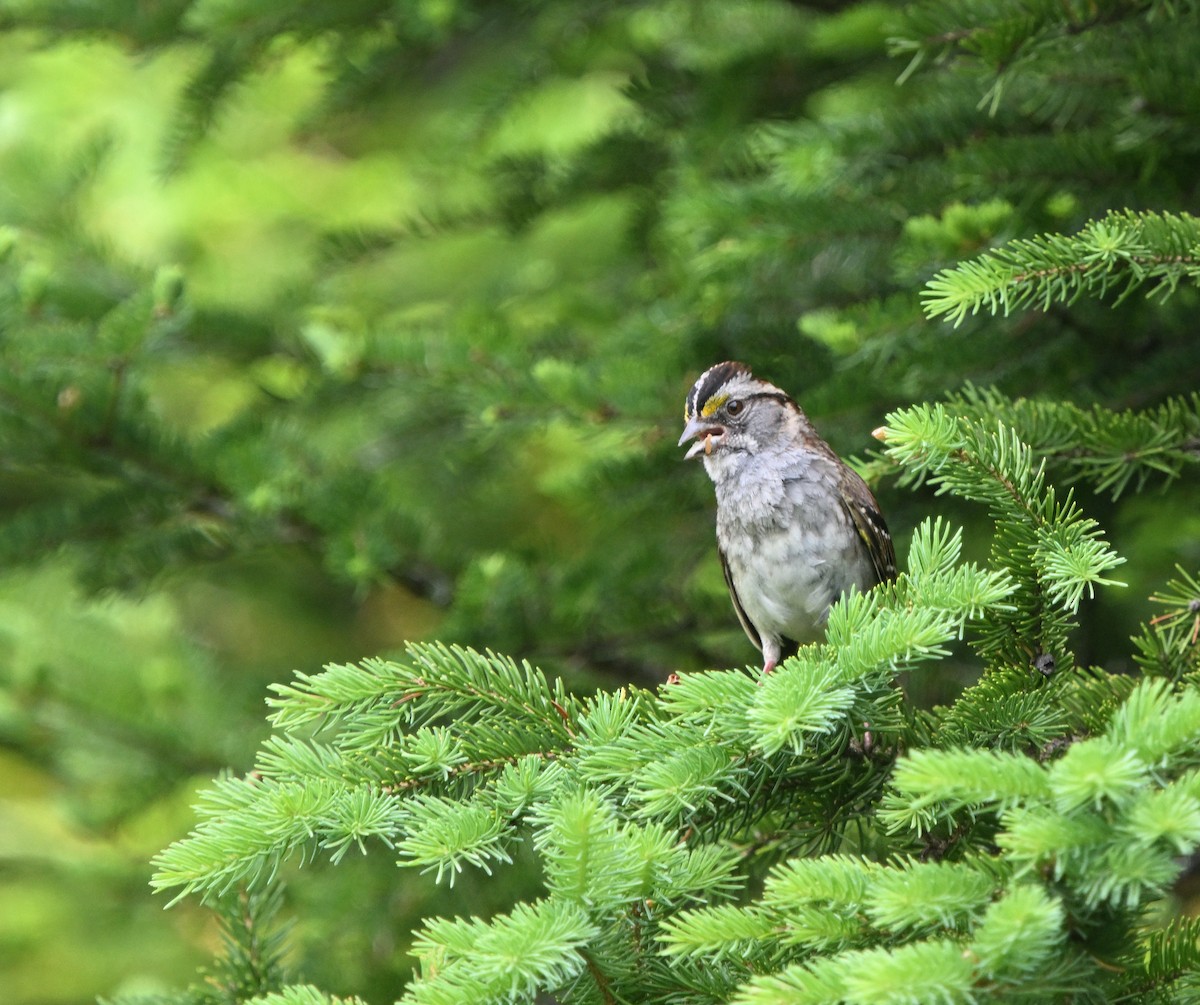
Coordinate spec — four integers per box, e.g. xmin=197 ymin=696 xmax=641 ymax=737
xmin=0 ymin=0 xmax=1200 ymax=1005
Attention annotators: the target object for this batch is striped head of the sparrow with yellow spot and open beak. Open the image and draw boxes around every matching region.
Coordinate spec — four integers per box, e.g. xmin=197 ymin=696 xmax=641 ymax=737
xmin=679 ymin=362 xmax=799 ymax=459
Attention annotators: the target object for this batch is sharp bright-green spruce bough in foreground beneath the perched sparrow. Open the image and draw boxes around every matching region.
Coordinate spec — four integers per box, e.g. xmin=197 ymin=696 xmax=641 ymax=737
xmin=147 ymin=399 xmax=1200 ymax=1005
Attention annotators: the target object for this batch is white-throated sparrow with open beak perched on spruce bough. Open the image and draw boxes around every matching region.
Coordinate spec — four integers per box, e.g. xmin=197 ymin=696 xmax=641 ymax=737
xmin=678 ymin=361 xmax=896 ymax=674
